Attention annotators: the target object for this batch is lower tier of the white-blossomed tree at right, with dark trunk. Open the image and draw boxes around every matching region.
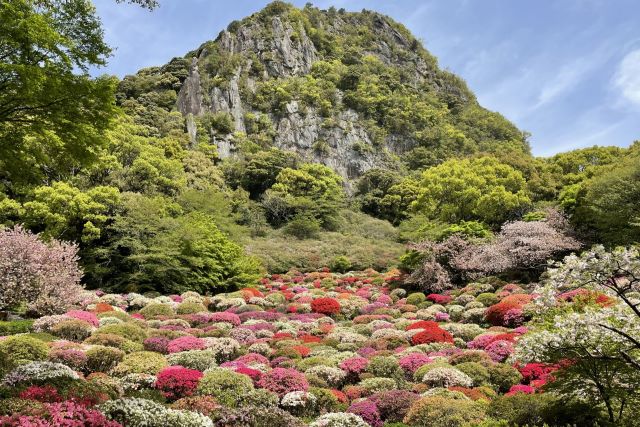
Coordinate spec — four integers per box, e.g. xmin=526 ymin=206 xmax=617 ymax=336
xmin=513 ymin=305 xmax=640 ymax=423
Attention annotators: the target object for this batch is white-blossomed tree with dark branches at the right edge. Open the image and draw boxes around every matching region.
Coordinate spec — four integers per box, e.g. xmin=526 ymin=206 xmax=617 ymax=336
xmin=513 ymin=246 xmax=640 ymax=423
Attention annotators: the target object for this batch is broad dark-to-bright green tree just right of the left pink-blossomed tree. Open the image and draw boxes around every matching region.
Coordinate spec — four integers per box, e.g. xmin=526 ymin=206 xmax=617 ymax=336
xmin=85 ymin=193 xmax=260 ymax=294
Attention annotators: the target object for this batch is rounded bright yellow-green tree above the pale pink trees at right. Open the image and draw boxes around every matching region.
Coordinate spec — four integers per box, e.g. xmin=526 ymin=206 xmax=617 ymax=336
xmin=413 ymin=157 xmax=531 ymax=225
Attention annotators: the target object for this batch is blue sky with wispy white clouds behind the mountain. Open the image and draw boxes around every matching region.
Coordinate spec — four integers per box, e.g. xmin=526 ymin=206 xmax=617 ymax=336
xmin=95 ymin=0 xmax=640 ymax=156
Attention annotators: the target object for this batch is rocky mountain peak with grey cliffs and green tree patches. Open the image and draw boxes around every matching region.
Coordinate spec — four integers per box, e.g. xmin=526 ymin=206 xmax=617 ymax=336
xmin=119 ymin=2 xmax=529 ymax=188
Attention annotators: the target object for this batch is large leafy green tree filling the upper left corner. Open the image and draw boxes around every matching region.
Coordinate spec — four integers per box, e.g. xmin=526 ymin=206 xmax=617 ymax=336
xmin=0 ymin=0 xmax=116 ymax=182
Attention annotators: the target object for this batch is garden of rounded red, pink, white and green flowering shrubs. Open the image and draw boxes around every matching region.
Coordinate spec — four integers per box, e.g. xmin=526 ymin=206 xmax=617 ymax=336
xmin=0 ymin=264 xmax=620 ymax=427
